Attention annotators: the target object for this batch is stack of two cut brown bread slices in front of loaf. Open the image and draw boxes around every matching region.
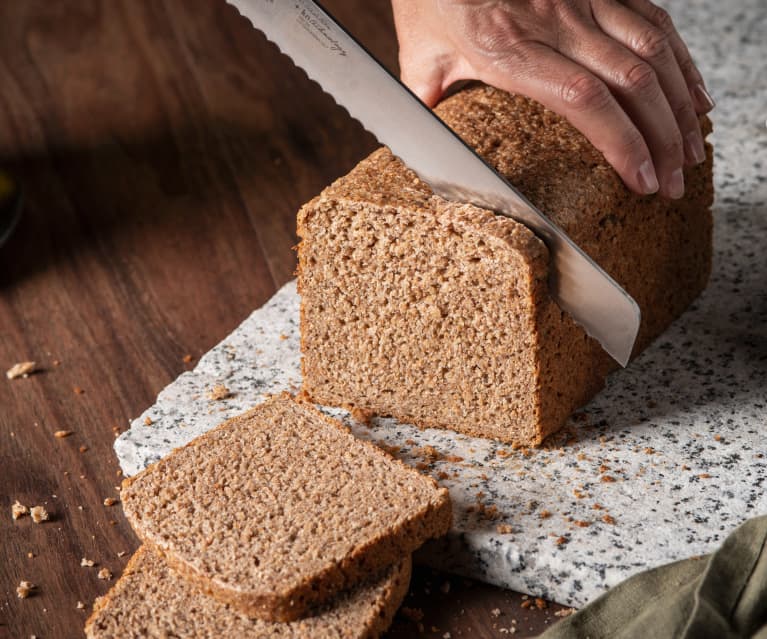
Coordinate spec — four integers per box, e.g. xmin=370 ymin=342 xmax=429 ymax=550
xmin=85 ymin=394 xmax=451 ymax=638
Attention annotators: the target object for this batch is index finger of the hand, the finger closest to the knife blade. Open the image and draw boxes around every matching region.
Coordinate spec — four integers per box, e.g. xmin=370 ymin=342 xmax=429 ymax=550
xmin=476 ymin=42 xmax=659 ymax=195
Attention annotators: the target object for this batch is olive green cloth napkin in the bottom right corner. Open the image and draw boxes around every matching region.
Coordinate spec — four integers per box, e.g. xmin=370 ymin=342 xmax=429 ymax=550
xmin=541 ymin=516 xmax=767 ymax=639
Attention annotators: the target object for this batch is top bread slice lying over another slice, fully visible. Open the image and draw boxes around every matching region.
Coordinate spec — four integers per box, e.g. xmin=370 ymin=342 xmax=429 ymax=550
xmin=121 ymin=394 xmax=451 ymax=621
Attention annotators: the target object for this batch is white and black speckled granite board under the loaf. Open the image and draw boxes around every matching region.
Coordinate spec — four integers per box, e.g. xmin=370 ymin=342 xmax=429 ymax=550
xmin=115 ymin=0 xmax=767 ymax=605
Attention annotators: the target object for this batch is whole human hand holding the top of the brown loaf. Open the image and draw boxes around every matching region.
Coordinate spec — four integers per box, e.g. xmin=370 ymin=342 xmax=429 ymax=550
xmin=392 ymin=0 xmax=714 ymax=199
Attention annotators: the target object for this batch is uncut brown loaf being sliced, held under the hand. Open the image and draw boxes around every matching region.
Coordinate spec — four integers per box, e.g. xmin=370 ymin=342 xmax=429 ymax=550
xmin=298 ymin=86 xmax=713 ymax=445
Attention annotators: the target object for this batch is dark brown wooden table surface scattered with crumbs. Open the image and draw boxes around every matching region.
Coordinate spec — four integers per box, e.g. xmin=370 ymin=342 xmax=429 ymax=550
xmin=0 ymin=0 xmax=572 ymax=638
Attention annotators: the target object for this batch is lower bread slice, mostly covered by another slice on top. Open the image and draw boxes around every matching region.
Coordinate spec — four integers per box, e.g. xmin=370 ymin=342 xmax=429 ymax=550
xmin=85 ymin=546 xmax=410 ymax=639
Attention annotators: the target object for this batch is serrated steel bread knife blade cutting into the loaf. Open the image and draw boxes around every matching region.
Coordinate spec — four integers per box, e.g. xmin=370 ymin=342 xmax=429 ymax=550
xmin=229 ymin=0 xmax=641 ymax=366
